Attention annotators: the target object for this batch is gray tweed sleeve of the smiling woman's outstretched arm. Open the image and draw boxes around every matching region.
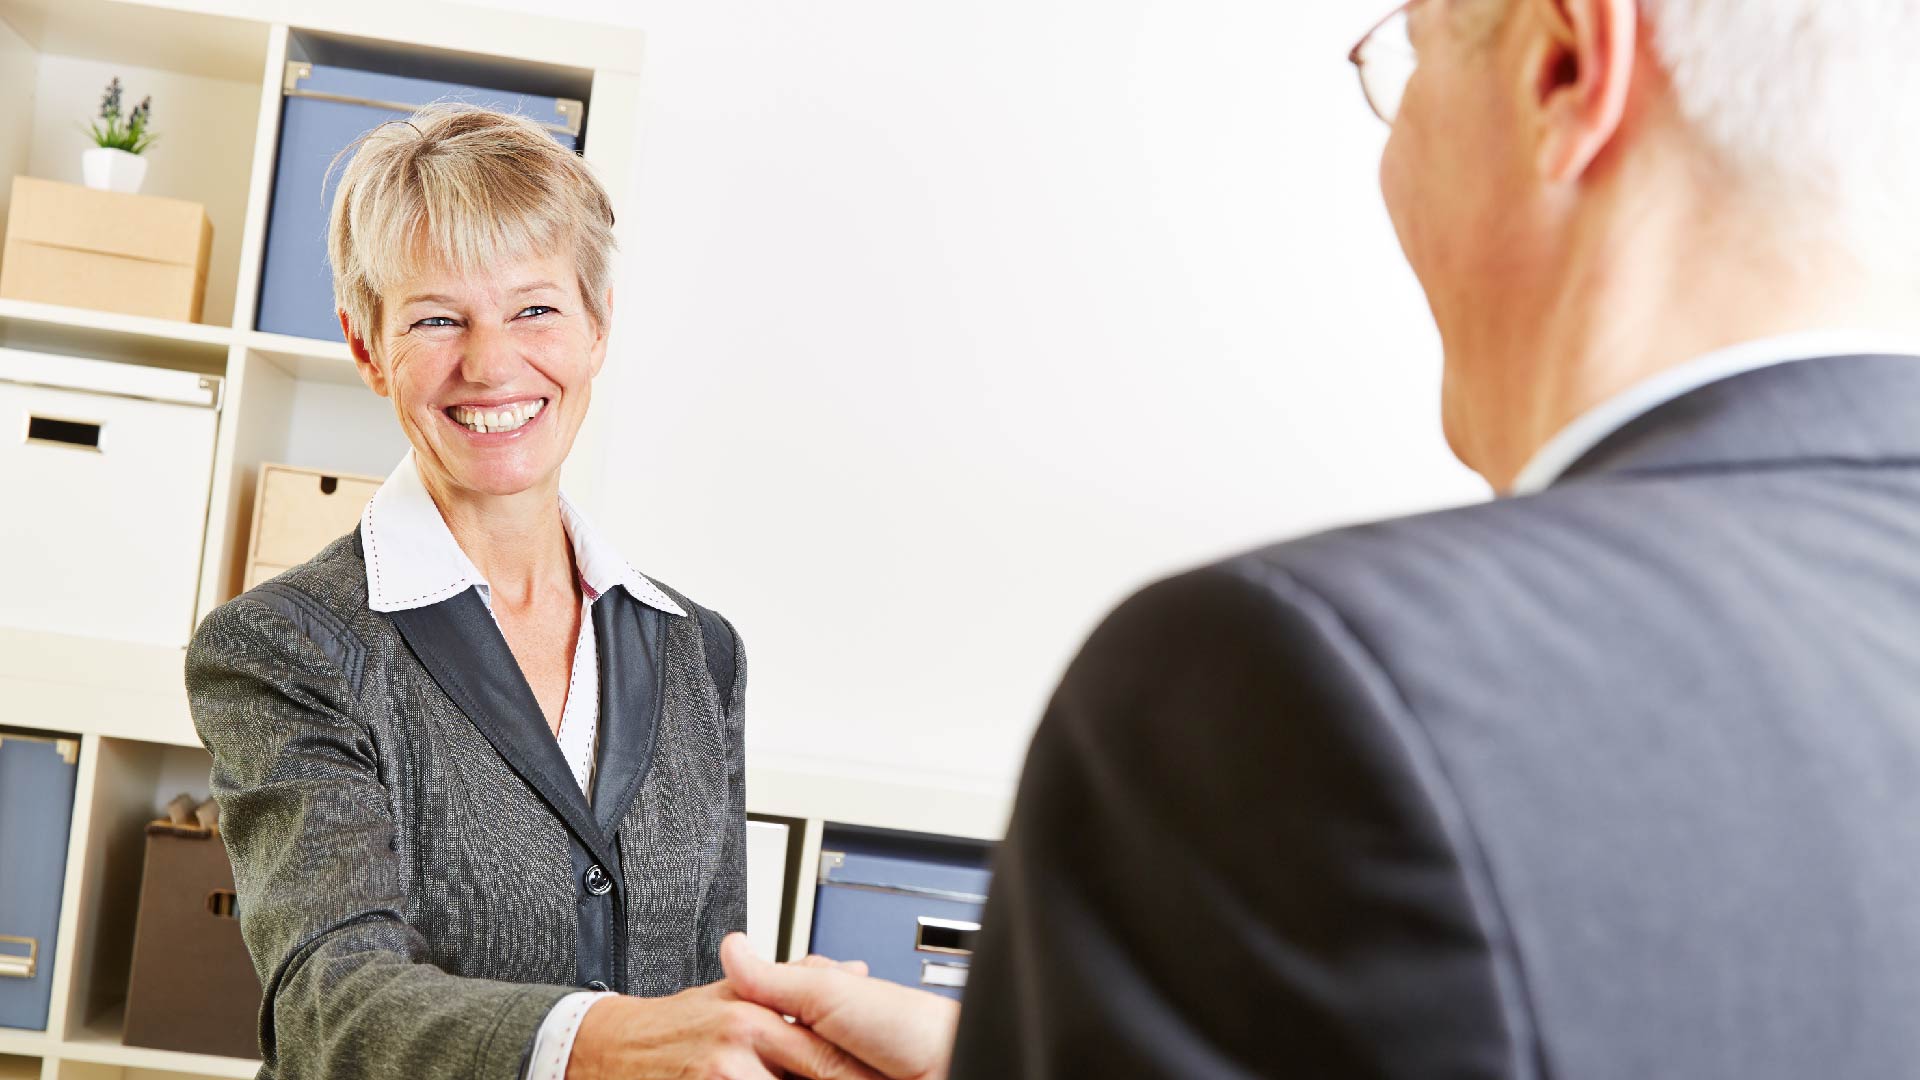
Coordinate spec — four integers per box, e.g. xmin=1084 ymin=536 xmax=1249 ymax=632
xmin=186 ymin=596 xmax=572 ymax=1080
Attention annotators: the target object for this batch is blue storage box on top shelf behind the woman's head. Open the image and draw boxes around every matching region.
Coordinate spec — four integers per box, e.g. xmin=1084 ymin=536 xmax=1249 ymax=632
xmin=253 ymin=60 xmax=586 ymax=342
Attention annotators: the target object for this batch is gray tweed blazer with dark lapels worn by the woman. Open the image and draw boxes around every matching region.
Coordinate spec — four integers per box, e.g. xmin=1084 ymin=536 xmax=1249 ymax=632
xmin=186 ymin=528 xmax=747 ymax=1080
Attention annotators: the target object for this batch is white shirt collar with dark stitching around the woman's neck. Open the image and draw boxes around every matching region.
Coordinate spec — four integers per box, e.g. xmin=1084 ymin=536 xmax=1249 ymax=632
xmin=361 ymin=448 xmax=685 ymax=617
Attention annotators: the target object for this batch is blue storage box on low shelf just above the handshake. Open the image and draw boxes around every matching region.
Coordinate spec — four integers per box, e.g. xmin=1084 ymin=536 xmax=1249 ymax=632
xmin=810 ymin=826 xmax=993 ymax=997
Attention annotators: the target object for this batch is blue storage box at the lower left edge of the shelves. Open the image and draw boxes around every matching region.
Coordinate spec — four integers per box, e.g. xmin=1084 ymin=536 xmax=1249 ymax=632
xmin=0 ymin=730 xmax=81 ymax=1030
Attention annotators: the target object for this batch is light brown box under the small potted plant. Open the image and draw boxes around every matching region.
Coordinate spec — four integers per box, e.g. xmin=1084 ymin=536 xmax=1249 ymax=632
xmin=0 ymin=177 xmax=213 ymax=323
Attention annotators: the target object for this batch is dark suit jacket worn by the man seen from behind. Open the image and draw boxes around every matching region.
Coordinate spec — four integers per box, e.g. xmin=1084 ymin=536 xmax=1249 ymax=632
xmin=954 ymin=357 xmax=1920 ymax=1080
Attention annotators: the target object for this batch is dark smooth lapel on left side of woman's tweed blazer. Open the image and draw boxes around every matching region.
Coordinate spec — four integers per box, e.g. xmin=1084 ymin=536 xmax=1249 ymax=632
xmin=388 ymin=588 xmax=618 ymax=865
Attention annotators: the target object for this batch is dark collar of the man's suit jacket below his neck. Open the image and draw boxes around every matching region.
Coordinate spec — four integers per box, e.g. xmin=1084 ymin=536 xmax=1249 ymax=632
xmin=1559 ymin=356 xmax=1920 ymax=482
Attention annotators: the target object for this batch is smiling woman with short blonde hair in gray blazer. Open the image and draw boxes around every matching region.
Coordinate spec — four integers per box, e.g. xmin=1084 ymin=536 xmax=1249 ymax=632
xmin=186 ymin=106 xmax=824 ymax=1080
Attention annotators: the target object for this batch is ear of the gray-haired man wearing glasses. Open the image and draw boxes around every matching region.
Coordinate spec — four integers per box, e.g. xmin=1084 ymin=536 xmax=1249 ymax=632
xmin=1521 ymin=0 xmax=1640 ymax=183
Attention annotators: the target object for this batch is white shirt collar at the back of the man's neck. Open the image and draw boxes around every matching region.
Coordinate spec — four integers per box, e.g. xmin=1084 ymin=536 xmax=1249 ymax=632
xmin=1507 ymin=331 xmax=1920 ymax=496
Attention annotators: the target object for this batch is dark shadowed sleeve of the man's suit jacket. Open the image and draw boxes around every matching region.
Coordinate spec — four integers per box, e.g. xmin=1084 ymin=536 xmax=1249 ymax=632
xmin=952 ymin=561 xmax=1517 ymax=1080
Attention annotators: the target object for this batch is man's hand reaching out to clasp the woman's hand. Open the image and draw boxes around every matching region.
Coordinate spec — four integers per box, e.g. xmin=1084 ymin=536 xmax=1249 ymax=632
xmin=720 ymin=934 xmax=960 ymax=1080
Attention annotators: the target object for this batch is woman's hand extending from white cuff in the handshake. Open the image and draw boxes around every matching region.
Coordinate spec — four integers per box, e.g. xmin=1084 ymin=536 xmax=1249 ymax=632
xmin=566 ymin=976 xmax=881 ymax=1080
